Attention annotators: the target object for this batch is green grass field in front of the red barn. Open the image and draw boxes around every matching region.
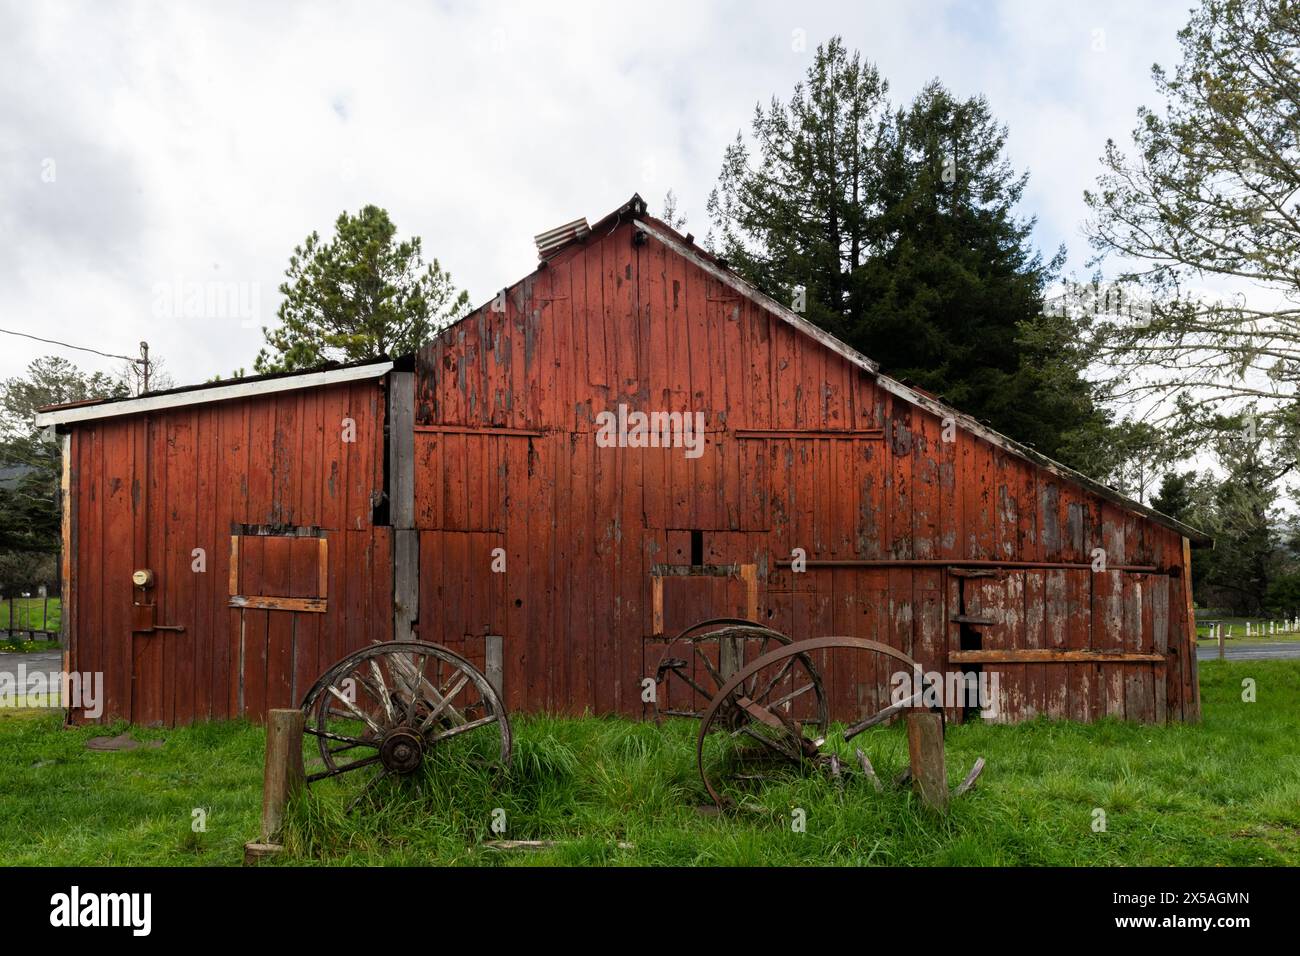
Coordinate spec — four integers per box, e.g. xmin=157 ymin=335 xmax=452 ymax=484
xmin=0 ymin=661 xmax=1300 ymax=866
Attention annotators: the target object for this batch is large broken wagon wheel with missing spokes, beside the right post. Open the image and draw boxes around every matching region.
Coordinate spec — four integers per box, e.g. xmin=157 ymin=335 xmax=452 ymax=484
xmin=696 ymin=637 xmax=922 ymax=806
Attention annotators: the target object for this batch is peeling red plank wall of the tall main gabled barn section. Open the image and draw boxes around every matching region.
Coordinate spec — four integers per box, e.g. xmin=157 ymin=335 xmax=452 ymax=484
xmin=416 ymin=208 xmax=1196 ymax=721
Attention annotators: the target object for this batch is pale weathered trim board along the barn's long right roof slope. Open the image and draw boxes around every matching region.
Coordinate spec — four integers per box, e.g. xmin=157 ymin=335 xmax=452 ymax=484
xmin=634 ymin=220 xmax=1214 ymax=548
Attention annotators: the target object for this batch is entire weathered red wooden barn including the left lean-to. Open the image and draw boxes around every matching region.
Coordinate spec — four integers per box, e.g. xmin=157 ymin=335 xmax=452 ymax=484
xmin=38 ymin=196 xmax=1204 ymax=724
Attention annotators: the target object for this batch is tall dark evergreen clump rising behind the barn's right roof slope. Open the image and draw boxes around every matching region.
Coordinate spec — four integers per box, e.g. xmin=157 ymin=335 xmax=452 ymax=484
xmin=709 ymin=38 xmax=1114 ymax=476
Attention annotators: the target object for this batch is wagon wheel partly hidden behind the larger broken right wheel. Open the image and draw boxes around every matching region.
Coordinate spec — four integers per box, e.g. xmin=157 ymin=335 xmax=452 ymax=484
xmin=654 ymin=618 xmax=828 ymax=727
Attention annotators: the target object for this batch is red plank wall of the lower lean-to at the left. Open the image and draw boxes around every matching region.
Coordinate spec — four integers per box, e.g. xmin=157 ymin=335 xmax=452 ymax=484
xmin=69 ymin=381 xmax=391 ymax=724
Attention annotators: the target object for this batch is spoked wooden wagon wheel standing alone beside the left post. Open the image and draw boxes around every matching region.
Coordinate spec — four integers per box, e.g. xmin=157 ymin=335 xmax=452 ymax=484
xmin=303 ymin=641 xmax=511 ymax=810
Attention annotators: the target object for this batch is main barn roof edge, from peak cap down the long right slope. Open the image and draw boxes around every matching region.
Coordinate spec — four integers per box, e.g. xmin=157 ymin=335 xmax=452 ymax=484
xmin=547 ymin=194 xmax=1214 ymax=548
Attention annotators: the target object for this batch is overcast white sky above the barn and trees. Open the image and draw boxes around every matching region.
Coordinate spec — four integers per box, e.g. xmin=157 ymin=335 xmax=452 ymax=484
xmin=0 ymin=0 xmax=1188 ymax=384
